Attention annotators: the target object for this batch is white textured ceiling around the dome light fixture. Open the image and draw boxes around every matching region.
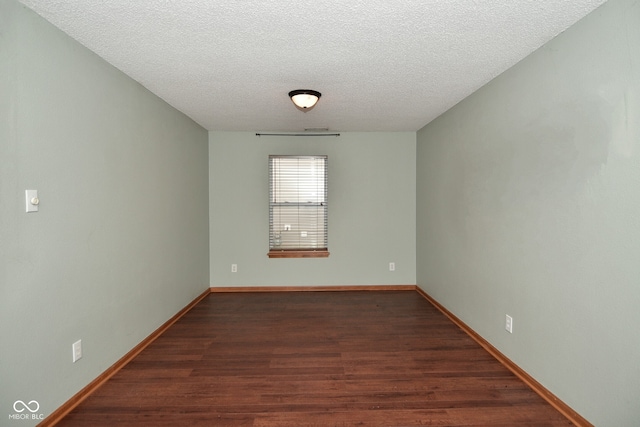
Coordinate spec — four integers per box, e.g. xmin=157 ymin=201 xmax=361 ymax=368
xmin=21 ymin=0 xmax=605 ymax=131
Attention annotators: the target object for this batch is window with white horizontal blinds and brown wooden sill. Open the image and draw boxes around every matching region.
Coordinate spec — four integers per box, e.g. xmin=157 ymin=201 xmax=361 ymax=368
xmin=269 ymin=156 xmax=329 ymax=258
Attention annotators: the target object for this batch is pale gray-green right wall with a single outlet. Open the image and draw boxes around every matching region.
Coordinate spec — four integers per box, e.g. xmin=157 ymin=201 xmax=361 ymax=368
xmin=417 ymin=0 xmax=640 ymax=427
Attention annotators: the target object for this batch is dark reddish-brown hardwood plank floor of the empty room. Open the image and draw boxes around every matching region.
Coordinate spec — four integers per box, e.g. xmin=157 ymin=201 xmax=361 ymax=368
xmin=58 ymin=291 xmax=572 ymax=427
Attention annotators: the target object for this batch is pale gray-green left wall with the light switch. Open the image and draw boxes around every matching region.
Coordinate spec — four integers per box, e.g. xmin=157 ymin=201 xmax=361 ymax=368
xmin=0 ymin=0 xmax=209 ymax=425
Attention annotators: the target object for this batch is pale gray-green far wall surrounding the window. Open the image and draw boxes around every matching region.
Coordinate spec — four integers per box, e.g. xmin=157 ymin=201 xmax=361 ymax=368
xmin=209 ymin=131 xmax=416 ymax=287
